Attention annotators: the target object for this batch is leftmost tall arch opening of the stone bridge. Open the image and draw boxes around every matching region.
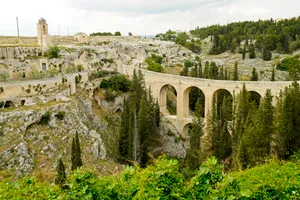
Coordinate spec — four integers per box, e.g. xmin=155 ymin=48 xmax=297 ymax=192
xmin=159 ymin=84 xmax=178 ymax=115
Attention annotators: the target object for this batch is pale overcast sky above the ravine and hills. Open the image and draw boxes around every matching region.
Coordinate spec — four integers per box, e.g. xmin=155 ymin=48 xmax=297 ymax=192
xmin=0 ymin=0 xmax=300 ymax=36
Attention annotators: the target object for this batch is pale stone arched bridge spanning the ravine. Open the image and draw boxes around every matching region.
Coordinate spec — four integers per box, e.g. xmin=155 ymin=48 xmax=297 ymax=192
xmin=118 ymin=66 xmax=292 ymax=137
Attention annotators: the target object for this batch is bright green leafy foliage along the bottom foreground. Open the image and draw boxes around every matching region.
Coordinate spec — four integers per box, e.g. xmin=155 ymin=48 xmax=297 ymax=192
xmin=0 ymin=156 xmax=300 ymax=199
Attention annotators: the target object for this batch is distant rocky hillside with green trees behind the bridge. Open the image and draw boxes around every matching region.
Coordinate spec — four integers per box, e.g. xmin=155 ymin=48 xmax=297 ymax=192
xmin=156 ymin=18 xmax=300 ymax=80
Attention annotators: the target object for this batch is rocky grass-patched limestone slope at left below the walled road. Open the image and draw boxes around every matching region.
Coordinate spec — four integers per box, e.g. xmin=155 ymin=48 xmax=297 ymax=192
xmin=0 ymin=95 xmax=117 ymax=177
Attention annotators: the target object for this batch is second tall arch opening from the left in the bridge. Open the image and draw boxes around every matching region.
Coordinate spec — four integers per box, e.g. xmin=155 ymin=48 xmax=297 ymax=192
xmin=182 ymin=86 xmax=206 ymax=118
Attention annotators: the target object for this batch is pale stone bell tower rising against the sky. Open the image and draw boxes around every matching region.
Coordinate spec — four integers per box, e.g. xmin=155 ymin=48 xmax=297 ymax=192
xmin=37 ymin=18 xmax=51 ymax=48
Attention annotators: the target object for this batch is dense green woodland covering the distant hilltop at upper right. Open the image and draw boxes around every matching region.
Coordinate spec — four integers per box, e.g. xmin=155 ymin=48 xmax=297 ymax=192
xmin=191 ymin=17 xmax=300 ymax=54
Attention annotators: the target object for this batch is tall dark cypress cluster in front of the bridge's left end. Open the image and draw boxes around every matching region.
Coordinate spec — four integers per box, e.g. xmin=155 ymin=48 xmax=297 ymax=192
xmin=119 ymin=71 xmax=160 ymax=167
